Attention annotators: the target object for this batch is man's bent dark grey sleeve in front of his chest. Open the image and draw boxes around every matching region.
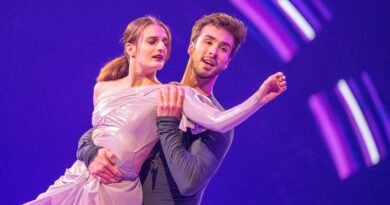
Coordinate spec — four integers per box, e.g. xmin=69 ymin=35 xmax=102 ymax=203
xmin=157 ymin=117 xmax=232 ymax=196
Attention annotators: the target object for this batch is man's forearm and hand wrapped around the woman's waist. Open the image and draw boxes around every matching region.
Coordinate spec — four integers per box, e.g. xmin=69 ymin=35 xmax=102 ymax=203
xmin=77 ymin=129 xmax=122 ymax=184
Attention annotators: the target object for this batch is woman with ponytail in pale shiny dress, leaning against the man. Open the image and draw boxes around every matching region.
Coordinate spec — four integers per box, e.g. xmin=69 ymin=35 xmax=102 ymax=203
xmin=28 ymin=17 xmax=285 ymax=204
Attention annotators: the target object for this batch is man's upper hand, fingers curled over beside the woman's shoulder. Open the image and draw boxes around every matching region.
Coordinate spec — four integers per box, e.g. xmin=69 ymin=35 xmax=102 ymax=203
xmin=157 ymin=85 xmax=184 ymax=120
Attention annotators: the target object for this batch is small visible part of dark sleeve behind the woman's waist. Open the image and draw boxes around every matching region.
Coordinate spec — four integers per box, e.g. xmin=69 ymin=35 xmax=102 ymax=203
xmin=77 ymin=128 xmax=102 ymax=167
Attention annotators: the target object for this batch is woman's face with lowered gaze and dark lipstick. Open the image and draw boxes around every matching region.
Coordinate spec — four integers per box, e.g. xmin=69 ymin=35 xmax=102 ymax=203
xmin=134 ymin=24 xmax=169 ymax=74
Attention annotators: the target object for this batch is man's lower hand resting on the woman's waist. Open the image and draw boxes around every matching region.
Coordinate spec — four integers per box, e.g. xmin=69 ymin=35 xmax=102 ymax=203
xmin=88 ymin=148 xmax=123 ymax=184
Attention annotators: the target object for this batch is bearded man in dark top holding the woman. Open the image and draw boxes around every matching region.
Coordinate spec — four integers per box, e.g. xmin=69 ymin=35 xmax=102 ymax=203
xmin=77 ymin=13 xmax=285 ymax=204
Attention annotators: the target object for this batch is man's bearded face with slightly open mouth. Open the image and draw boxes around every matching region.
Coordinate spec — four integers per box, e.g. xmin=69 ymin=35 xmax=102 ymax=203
xmin=188 ymin=25 xmax=234 ymax=79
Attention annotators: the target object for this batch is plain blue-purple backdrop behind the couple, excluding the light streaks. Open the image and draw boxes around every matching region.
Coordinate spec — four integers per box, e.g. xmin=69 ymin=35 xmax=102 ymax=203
xmin=0 ymin=0 xmax=390 ymax=204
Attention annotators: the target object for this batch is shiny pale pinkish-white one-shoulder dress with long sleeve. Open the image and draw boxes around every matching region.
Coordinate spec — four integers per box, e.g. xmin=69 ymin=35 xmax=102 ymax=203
xmin=27 ymin=85 xmax=260 ymax=205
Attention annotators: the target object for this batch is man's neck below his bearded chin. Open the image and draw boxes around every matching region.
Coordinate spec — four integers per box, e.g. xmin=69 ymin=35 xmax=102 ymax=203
xmin=181 ymin=62 xmax=217 ymax=96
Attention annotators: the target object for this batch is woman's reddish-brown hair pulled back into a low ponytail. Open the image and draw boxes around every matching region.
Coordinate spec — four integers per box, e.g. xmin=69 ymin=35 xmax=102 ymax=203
xmin=96 ymin=16 xmax=172 ymax=82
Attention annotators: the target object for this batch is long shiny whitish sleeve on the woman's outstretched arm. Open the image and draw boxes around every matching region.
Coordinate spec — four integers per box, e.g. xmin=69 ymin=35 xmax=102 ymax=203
xmin=183 ymin=87 xmax=261 ymax=132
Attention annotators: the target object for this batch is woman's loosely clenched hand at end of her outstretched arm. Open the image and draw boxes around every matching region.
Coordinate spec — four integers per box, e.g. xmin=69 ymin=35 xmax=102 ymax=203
xmin=256 ymin=72 xmax=287 ymax=105
